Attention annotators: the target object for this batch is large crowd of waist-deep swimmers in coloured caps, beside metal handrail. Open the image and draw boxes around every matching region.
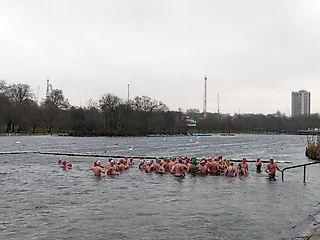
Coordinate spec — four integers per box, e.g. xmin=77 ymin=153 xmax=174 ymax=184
xmin=90 ymin=155 xmax=281 ymax=180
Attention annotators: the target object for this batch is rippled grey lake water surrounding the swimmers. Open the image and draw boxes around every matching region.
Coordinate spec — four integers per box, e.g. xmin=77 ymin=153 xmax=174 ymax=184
xmin=0 ymin=135 xmax=320 ymax=240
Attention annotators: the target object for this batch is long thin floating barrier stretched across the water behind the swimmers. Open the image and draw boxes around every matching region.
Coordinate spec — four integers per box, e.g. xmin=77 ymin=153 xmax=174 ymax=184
xmin=0 ymin=151 xmax=292 ymax=163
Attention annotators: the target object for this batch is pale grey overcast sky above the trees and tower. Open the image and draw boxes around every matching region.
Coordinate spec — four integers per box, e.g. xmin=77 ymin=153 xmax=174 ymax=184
xmin=0 ymin=0 xmax=320 ymax=114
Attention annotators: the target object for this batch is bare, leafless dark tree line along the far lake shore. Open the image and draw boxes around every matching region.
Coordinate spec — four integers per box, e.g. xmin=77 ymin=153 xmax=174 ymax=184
xmin=0 ymin=80 xmax=320 ymax=136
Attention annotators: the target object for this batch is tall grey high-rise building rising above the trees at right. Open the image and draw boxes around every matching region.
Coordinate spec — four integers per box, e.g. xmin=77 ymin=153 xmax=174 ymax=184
xmin=291 ymin=90 xmax=310 ymax=117
